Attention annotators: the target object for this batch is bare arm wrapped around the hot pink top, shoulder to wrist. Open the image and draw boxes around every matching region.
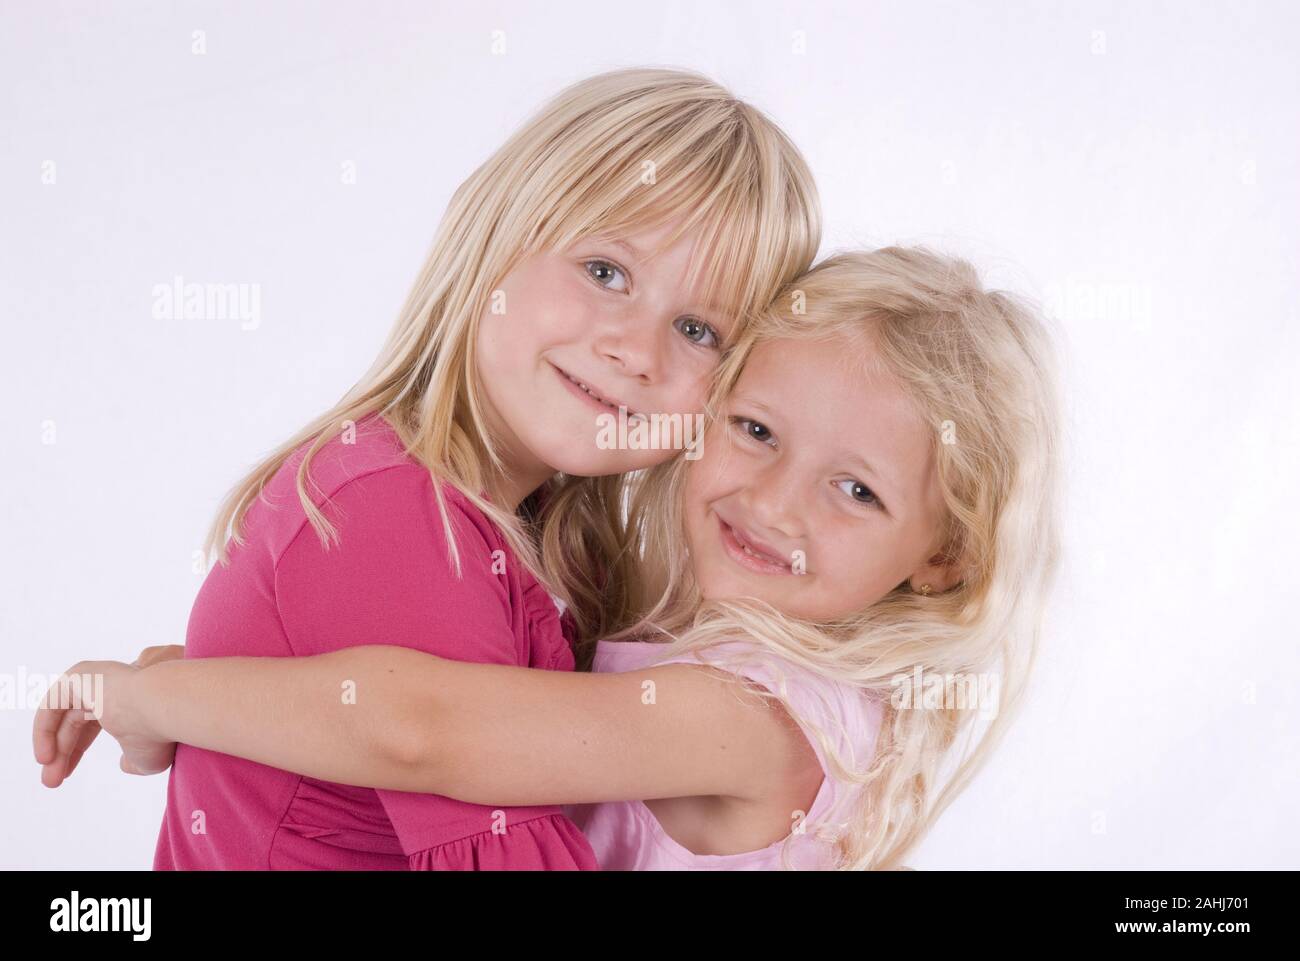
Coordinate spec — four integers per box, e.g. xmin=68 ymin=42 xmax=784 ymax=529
xmin=124 ymin=646 xmax=815 ymax=805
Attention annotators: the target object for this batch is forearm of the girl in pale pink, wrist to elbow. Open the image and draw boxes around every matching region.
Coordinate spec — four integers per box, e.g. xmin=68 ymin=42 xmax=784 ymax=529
xmin=131 ymin=646 xmax=443 ymax=791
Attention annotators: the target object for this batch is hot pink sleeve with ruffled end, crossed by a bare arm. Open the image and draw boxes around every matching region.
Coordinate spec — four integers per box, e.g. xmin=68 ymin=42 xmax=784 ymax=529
xmin=276 ymin=464 xmax=597 ymax=870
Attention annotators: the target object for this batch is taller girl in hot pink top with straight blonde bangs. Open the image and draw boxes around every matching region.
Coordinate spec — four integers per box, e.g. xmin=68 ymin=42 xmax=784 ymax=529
xmin=36 ymin=69 xmax=820 ymax=870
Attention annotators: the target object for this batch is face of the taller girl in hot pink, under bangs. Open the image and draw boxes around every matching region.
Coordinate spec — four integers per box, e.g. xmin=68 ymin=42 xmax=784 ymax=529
xmin=477 ymin=217 xmax=731 ymax=484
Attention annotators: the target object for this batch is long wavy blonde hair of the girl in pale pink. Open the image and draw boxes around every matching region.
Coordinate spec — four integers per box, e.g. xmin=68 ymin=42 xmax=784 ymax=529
xmin=620 ymin=247 xmax=1060 ymax=869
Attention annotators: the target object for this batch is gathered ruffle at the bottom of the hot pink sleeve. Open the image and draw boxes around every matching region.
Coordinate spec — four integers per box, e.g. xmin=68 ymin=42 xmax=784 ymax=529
xmin=408 ymin=814 xmax=599 ymax=871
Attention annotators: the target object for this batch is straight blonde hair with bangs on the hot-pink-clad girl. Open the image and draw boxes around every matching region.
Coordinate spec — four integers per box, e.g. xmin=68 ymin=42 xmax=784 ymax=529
xmin=205 ymin=69 xmax=820 ymax=647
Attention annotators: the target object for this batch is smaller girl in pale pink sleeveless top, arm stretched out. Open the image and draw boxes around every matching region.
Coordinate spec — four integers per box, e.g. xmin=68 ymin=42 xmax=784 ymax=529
xmin=40 ymin=248 xmax=1057 ymax=870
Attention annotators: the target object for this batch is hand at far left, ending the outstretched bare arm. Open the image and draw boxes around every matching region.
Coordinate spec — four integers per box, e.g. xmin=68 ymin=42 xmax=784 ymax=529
xmin=33 ymin=660 xmax=176 ymax=788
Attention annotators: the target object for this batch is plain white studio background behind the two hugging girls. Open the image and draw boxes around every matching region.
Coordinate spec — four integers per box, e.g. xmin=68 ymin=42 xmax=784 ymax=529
xmin=0 ymin=0 xmax=1300 ymax=873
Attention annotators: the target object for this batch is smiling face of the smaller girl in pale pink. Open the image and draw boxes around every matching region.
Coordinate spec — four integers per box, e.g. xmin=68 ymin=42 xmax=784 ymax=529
xmin=685 ymin=338 xmax=948 ymax=620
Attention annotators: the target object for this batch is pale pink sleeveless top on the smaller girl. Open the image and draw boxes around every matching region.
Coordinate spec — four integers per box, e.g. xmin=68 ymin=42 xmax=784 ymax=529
xmin=566 ymin=641 xmax=884 ymax=871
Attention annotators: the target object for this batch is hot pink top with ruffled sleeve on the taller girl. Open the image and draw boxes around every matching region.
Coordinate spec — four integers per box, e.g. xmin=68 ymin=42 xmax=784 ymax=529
xmin=153 ymin=417 xmax=597 ymax=871
